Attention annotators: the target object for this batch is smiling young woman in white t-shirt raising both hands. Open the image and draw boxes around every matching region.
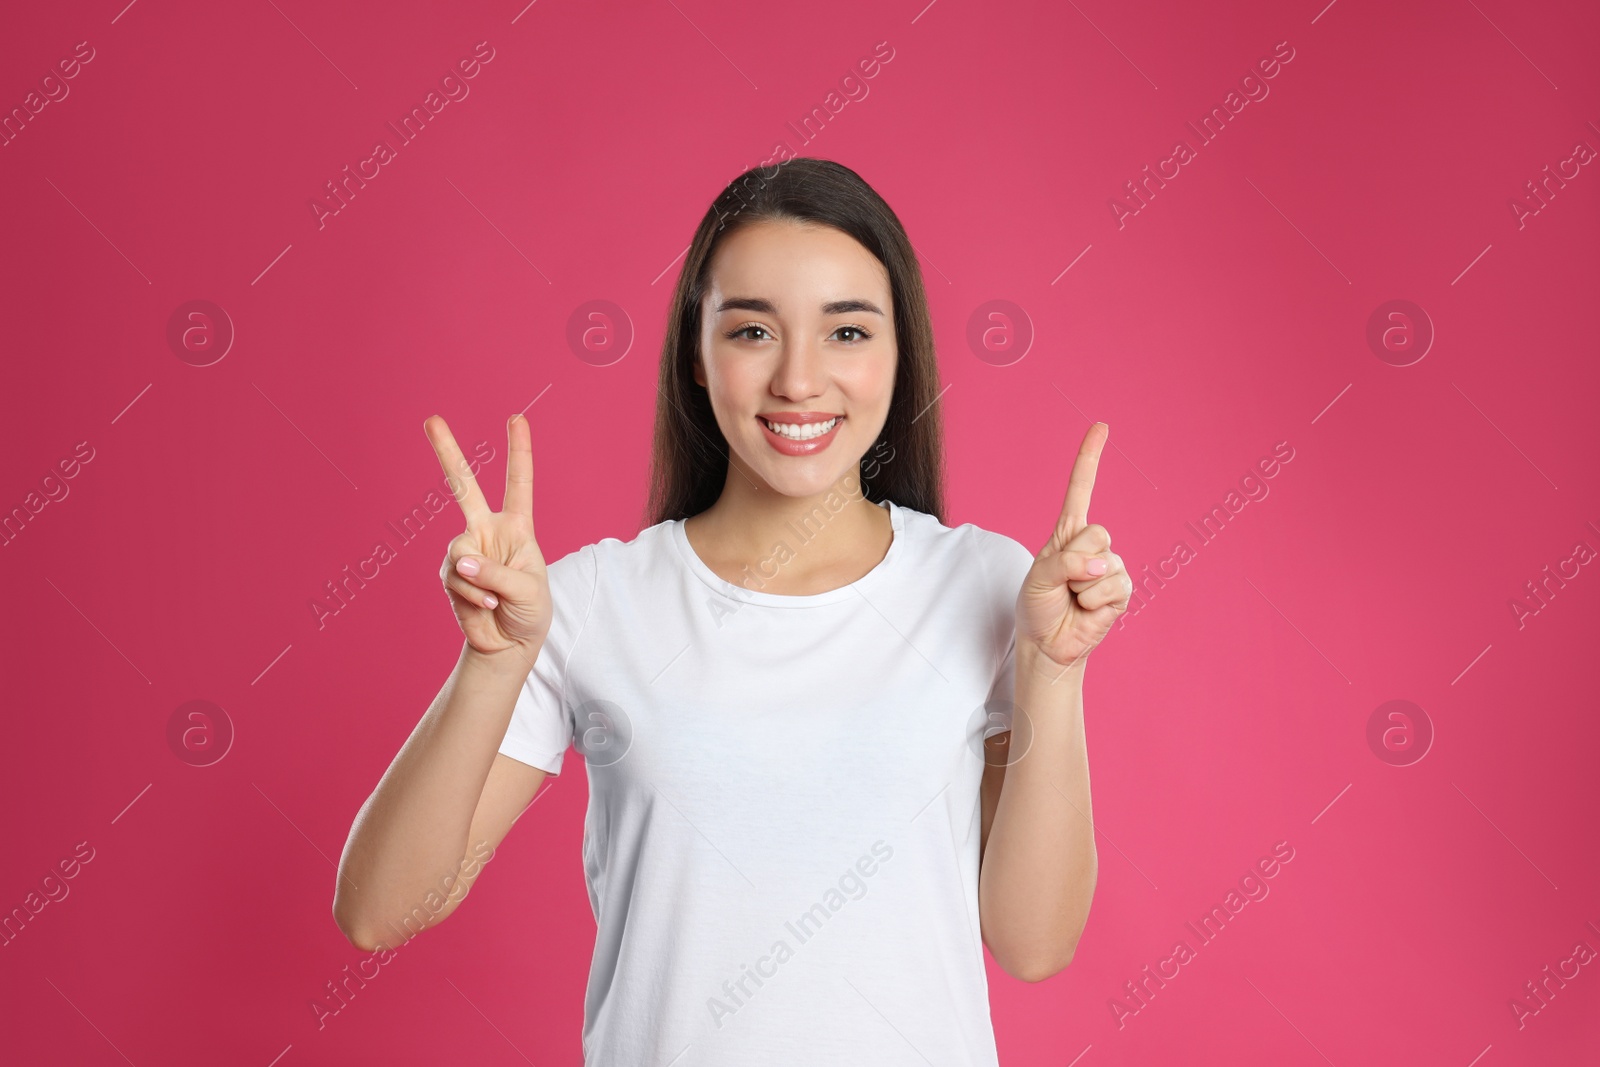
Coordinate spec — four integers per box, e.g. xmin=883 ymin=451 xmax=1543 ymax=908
xmin=334 ymin=158 xmax=1133 ymax=1067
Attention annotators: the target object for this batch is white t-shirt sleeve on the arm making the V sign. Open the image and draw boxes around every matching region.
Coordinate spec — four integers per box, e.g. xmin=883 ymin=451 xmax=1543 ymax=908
xmin=499 ymin=544 xmax=598 ymax=774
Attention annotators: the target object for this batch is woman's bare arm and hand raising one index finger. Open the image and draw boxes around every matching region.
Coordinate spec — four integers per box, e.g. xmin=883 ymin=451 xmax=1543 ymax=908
xmin=978 ymin=422 xmax=1133 ymax=982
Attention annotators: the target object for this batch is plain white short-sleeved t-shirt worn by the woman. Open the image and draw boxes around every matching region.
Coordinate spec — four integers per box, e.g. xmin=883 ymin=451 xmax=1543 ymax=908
xmin=499 ymin=504 xmax=1034 ymax=1067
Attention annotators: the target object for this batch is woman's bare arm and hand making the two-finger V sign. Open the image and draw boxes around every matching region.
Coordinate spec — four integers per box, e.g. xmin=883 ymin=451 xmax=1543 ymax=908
xmin=333 ymin=416 xmax=550 ymax=950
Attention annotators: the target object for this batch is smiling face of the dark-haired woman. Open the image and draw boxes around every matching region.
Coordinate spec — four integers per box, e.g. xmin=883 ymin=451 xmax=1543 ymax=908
xmin=694 ymin=221 xmax=898 ymax=498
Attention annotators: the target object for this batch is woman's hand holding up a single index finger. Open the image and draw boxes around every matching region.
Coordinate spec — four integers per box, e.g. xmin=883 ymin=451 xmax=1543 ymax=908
xmin=1016 ymin=422 xmax=1133 ymax=667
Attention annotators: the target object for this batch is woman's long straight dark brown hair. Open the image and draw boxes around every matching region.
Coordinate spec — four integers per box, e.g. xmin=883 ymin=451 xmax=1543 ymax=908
xmin=645 ymin=157 xmax=944 ymax=526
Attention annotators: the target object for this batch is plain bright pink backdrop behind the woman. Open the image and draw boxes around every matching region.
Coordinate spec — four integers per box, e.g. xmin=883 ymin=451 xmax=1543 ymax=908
xmin=0 ymin=0 xmax=1600 ymax=1067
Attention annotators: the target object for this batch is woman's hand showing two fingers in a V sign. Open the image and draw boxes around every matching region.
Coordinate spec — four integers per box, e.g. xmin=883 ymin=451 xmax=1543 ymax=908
xmin=422 ymin=414 xmax=550 ymax=664
